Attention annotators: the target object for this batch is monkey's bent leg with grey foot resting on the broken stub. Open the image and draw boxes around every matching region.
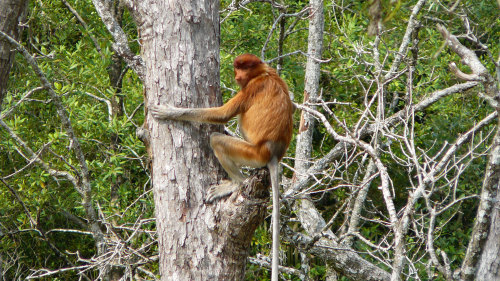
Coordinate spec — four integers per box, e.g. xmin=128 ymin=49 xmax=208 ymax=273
xmin=206 ymin=133 xmax=269 ymax=203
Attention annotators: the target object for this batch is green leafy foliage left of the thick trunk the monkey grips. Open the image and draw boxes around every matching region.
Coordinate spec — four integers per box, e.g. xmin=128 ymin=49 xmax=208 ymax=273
xmin=0 ymin=1 xmax=148 ymax=280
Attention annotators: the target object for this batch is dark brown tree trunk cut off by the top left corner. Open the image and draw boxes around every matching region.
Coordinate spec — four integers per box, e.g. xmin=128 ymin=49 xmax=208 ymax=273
xmin=0 ymin=0 xmax=28 ymax=109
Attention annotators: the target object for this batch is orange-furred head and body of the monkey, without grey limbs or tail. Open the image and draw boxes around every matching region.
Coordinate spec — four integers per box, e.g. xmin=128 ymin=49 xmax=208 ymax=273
xmin=214 ymin=54 xmax=294 ymax=166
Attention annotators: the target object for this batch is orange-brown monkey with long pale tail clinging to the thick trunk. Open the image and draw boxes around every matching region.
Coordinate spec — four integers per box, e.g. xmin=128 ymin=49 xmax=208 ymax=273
xmin=150 ymin=54 xmax=294 ymax=281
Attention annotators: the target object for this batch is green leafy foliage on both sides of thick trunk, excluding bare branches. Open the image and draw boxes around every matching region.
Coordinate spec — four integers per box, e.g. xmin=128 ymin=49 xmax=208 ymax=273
xmin=0 ymin=0 xmax=500 ymax=280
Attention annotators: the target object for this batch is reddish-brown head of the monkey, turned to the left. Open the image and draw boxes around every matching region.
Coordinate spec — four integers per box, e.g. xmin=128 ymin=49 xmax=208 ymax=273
xmin=233 ymin=54 xmax=266 ymax=88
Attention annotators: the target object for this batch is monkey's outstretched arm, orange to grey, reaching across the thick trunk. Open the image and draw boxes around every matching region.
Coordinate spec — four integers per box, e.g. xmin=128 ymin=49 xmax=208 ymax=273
xmin=149 ymin=95 xmax=241 ymax=124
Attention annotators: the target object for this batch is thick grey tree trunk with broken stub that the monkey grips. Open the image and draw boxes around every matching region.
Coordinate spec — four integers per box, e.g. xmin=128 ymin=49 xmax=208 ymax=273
xmin=129 ymin=0 xmax=269 ymax=281
